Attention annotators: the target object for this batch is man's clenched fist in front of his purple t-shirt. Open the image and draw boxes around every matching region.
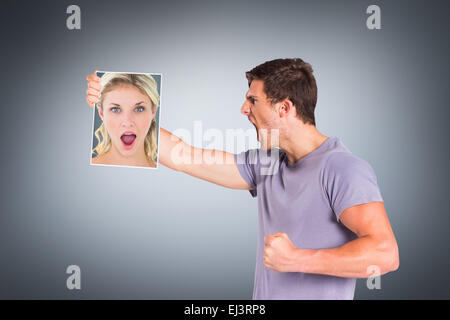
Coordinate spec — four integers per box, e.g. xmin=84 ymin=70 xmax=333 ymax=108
xmin=264 ymin=232 xmax=298 ymax=272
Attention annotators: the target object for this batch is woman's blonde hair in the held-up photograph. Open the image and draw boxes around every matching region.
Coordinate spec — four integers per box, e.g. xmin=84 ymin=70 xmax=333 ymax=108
xmin=92 ymin=72 xmax=159 ymax=162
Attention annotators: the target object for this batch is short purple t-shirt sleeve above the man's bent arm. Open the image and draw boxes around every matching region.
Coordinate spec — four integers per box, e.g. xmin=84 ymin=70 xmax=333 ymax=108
xmin=323 ymin=152 xmax=383 ymax=221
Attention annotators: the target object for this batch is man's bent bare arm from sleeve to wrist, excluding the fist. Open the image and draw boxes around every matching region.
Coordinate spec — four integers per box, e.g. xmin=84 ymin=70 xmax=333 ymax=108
xmin=294 ymin=202 xmax=399 ymax=278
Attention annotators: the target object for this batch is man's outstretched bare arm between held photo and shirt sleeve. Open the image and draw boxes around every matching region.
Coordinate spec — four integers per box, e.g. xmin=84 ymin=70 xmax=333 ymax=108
xmin=158 ymin=128 xmax=251 ymax=190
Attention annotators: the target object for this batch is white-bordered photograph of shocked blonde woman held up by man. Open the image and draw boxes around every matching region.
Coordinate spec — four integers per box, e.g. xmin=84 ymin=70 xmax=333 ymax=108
xmin=88 ymin=71 xmax=160 ymax=168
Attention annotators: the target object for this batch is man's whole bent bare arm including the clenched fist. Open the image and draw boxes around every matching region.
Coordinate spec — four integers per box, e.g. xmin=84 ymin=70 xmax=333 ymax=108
xmin=264 ymin=202 xmax=400 ymax=278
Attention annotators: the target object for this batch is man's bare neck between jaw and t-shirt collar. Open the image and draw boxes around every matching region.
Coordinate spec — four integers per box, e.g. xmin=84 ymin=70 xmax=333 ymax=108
xmin=280 ymin=125 xmax=328 ymax=163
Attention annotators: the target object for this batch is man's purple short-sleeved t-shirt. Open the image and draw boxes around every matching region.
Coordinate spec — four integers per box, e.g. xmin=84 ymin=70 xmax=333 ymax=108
xmin=235 ymin=137 xmax=383 ymax=300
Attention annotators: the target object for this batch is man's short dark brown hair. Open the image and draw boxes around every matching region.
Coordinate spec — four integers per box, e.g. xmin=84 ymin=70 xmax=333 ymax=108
xmin=245 ymin=58 xmax=317 ymax=125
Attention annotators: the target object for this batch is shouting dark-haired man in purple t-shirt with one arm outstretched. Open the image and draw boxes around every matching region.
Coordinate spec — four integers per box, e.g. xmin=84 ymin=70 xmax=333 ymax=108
xmin=87 ymin=59 xmax=399 ymax=299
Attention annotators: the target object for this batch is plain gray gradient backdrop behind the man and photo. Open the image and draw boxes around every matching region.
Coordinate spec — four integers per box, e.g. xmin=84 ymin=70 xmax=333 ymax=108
xmin=0 ymin=0 xmax=450 ymax=299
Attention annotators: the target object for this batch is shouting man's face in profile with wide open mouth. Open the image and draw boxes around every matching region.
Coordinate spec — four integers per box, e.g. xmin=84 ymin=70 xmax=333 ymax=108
xmin=241 ymin=80 xmax=279 ymax=149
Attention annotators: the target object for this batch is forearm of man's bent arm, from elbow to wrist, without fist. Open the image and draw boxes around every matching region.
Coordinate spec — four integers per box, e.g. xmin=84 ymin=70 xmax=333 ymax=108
xmin=294 ymin=236 xmax=398 ymax=278
